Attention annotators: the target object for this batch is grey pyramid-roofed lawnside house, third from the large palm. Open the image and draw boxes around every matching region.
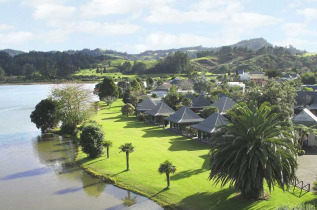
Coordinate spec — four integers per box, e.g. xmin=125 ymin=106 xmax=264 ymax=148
xmin=145 ymin=101 xmax=175 ymax=126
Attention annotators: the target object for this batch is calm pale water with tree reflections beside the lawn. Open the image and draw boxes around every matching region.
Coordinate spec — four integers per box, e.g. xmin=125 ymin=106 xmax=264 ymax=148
xmin=0 ymin=85 xmax=161 ymax=209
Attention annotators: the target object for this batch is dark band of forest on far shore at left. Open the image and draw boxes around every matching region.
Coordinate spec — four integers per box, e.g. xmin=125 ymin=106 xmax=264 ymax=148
xmin=0 ymin=51 xmax=101 ymax=78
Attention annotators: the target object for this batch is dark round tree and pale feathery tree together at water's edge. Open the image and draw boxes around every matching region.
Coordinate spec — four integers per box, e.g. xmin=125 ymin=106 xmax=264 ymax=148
xmin=30 ymin=84 xmax=93 ymax=134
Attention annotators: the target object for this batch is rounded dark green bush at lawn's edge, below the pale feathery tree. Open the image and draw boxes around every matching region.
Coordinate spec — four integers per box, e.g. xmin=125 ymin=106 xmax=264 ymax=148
xmin=80 ymin=123 xmax=104 ymax=158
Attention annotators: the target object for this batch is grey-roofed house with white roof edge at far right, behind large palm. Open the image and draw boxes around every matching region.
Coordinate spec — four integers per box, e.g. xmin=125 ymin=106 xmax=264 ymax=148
xmin=292 ymin=108 xmax=317 ymax=146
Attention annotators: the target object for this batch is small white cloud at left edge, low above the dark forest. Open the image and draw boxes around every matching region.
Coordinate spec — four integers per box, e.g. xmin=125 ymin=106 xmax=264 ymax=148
xmin=0 ymin=31 xmax=34 ymax=46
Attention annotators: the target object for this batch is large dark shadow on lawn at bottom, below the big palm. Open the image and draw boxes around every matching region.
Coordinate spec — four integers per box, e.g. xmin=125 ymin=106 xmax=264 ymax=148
xmin=179 ymin=188 xmax=267 ymax=210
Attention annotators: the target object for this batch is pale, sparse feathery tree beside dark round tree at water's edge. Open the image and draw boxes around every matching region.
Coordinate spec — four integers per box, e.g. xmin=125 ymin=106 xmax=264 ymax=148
xmin=52 ymin=84 xmax=93 ymax=134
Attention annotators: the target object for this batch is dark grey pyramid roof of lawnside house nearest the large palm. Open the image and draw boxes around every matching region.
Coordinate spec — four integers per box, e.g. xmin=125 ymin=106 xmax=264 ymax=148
xmin=191 ymin=113 xmax=229 ymax=133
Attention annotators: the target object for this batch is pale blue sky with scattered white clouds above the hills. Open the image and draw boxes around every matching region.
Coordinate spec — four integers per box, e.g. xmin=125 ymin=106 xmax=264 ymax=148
xmin=0 ymin=0 xmax=317 ymax=53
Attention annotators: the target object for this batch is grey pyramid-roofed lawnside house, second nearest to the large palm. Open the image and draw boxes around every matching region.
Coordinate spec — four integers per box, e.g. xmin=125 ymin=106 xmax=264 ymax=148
xmin=165 ymin=106 xmax=204 ymax=133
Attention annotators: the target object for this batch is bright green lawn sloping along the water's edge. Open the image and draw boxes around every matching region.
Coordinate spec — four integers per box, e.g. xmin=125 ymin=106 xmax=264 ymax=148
xmin=77 ymin=101 xmax=315 ymax=209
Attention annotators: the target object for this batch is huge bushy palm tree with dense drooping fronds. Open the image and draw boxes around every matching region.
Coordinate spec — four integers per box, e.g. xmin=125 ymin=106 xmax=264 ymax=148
xmin=209 ymin=101 xmax=297 ymax=199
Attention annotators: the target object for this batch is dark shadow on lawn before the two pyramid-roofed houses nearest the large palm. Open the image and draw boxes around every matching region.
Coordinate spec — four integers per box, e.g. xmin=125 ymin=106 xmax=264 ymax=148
xmin=168 ymin=137 xmax=207 ymax=151
